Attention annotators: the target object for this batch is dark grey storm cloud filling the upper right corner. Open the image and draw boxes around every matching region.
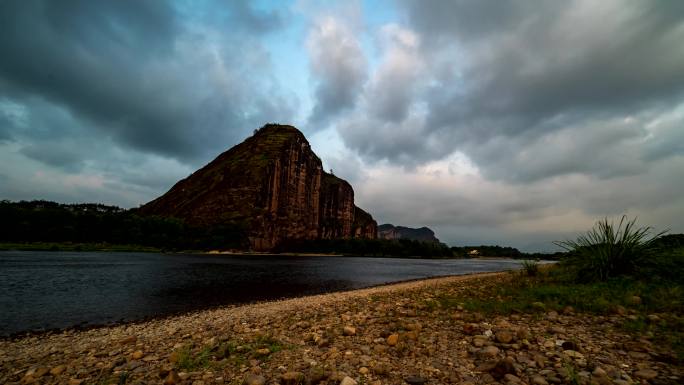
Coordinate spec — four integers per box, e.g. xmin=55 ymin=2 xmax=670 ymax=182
xmin=400 ymin=1 xmax=684 ymax=130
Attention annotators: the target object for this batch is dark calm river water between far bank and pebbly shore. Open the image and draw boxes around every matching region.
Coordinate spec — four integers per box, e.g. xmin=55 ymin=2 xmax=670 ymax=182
xmin=0 ymin=251 xmax=519 ymax=336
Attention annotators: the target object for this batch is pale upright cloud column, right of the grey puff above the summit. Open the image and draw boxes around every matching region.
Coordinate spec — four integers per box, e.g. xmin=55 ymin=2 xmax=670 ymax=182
xmin=336 ymin=24 xmax=432 ymax=165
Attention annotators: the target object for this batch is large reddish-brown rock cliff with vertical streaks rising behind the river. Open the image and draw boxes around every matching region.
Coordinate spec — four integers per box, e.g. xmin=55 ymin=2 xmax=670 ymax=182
xmin=140 ymin=124 xmax=377 ymax=250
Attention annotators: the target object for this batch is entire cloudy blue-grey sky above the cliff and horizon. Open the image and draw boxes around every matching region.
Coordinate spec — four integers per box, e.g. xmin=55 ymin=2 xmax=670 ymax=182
xmin=0 ymin=0 xmax=684 ymax=251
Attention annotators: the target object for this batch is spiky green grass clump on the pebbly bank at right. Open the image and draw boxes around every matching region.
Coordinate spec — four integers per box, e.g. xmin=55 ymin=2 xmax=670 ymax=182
xmin=554 ymin=215 xmax=665 ymax=281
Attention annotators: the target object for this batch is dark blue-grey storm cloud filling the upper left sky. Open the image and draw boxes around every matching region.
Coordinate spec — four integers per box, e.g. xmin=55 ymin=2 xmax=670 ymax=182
xmin=0 ymin=0 xmax=291 ymax=164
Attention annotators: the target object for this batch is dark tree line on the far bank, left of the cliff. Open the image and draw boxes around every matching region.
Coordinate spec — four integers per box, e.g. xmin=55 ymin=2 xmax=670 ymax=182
xmin=0 ymin=201 xmax=247 ymax=250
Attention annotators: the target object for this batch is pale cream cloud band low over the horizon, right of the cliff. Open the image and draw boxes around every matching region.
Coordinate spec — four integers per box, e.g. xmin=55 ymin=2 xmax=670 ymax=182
xmin=355 ymin=155 xmax=684 ymax=250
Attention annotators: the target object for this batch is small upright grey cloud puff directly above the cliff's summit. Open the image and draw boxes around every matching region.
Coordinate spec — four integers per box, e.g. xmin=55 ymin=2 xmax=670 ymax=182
xmin=307 ymin=16 xmax=367 ymax=124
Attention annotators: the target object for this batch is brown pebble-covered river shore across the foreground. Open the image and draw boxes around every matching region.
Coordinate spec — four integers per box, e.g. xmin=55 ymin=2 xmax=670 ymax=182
xmin=0 ymin=273 xmax=684 ymax=385
